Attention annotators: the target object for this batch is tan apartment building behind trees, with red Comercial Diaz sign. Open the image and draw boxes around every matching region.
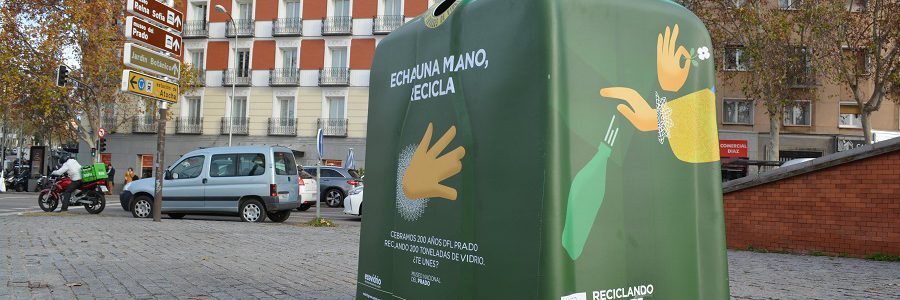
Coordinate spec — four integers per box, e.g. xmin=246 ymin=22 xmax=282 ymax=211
xmin=704 ymin=0 xmax=900 ymax=179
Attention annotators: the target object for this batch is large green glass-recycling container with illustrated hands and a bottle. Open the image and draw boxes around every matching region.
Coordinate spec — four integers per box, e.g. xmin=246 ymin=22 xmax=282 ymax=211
xmin=356 ymin=0 xmax=729 ymax=300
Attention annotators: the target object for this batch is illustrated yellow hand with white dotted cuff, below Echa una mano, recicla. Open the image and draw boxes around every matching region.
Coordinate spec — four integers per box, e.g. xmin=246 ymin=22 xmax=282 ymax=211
xmin=403 ymin=123 xmax=466 ymax=200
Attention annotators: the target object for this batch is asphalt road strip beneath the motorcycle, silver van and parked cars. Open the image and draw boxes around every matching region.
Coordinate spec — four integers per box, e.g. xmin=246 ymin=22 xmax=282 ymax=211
xmin=0 ymin=192 xmax=361 ymax=226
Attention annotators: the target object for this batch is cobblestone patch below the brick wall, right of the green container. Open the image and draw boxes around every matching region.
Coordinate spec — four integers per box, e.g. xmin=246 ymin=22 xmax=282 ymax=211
xmin=728 ymin=251 xmax=900 ymax=299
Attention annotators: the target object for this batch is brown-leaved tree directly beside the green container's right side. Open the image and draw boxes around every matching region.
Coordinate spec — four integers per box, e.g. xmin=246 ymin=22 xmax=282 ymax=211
xmin=690 ymin=0 xmax=821 ymax=161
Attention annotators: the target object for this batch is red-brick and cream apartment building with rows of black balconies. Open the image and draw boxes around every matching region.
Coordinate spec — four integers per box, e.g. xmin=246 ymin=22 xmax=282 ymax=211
xmin=92 ymin=0 xmax=433 ymax=176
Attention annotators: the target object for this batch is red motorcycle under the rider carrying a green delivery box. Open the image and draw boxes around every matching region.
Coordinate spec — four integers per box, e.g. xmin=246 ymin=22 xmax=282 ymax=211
xmin=38 ymin=177 xmax=106 ymax=214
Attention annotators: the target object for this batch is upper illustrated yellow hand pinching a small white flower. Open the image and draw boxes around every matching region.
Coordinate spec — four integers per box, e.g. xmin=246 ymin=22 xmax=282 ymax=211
xmin=656 ymin=24 xmax=691 ymax=92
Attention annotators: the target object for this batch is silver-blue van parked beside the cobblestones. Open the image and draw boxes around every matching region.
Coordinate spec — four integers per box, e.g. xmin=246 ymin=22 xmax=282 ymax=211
xmin=120 ymin=146 xmax=302 ymax=222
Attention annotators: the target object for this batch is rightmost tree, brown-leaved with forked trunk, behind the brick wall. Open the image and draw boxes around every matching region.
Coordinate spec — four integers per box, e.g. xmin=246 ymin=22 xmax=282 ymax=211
xmin=818 ymin=0 xmax=900 ymax=143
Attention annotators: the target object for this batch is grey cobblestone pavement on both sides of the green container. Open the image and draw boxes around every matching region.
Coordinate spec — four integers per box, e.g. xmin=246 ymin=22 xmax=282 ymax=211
xmin=0 ymin=212 xmax=900 ymax=299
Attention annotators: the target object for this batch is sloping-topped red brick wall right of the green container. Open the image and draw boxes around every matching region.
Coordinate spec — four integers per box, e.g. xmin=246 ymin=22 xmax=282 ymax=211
xmin=724 ymin=151 xmax=900 ymax=256
